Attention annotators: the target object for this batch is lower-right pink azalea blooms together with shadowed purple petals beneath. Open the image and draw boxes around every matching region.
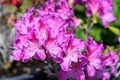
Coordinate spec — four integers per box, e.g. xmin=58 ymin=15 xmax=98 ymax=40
xmin=59 ymin=37 xmax=119 ymax=80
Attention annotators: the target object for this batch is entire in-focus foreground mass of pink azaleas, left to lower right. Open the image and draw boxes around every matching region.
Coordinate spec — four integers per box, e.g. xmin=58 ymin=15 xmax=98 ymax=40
xmin=12 ymin=0 xmax=119 ymax=80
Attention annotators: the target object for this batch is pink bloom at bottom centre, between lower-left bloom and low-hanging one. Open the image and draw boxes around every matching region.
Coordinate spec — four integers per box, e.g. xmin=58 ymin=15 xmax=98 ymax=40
xmin=45 ymin=32 xmax=71 ymax=63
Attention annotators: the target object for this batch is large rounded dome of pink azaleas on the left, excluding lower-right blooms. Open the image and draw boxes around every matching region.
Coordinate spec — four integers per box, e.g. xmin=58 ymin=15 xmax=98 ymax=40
xmin=12 ymin=0 xmax=82 ymax=62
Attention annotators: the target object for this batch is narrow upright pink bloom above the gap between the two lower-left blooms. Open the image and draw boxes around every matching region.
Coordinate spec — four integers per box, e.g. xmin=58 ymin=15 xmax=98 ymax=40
xmin=33 ymin=16 xmax=48 ymax=46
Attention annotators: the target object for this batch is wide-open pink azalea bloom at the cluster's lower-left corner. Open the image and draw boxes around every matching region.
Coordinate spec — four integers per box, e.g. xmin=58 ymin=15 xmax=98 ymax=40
xmin=12 ymin=32 xmax=46 ymax=62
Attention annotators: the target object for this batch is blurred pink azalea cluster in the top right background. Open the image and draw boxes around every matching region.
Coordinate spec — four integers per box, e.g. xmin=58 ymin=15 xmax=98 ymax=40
xmin=68 ymin=0 xmax=116 ymax=28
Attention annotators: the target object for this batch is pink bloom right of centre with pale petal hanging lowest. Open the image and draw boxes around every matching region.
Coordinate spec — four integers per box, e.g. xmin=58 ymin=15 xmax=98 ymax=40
xmin=60 ymin=37 xmax=84 ymax=71
